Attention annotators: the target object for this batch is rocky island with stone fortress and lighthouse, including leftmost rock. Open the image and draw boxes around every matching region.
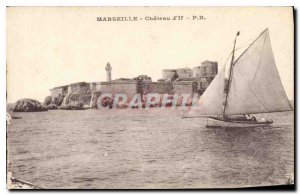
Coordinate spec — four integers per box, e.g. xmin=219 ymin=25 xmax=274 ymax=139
xmin=14 ymin=60 xmax=218 ymax=112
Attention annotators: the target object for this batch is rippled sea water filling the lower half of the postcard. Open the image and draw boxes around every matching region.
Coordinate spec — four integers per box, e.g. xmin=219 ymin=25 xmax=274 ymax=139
xmin=7 ymin=108 xmax=294 ymax=189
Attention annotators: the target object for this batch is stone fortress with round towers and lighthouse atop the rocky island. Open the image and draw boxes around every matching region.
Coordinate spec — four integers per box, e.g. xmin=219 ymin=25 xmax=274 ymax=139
xmin=50 ymin=60 xmax=218 ymax=103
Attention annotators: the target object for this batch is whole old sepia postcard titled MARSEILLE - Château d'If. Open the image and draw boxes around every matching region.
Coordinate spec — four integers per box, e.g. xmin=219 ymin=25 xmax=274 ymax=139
xmin=6 ymin=7 xmax=295 ymax=189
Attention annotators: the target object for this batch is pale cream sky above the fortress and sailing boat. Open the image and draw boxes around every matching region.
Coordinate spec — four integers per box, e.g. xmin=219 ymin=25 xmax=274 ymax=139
xmin=6 ymin=7 xmax=294 ymax=102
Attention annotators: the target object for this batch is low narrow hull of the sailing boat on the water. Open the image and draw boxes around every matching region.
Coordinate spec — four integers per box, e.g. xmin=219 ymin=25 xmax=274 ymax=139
xmin=206 ymin=119 xmax=272 ymax=128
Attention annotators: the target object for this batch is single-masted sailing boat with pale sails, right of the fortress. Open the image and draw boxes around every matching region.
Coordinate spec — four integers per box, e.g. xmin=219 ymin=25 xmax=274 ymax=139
xmin=187 ymin=29 xmax=293 ymax=128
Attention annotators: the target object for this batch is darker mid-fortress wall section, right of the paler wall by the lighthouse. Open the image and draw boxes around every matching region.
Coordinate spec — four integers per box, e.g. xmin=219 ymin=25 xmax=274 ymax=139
xmin=141 ymin=82 xmax=174 ymax=94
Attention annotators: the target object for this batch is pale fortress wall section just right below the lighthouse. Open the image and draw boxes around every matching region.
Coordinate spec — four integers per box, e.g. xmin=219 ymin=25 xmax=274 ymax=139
xmin=101 ymin=81 xmax=139 ymax=101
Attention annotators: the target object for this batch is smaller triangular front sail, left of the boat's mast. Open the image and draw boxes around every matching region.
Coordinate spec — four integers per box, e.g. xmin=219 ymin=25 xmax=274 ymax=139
xmin=188 ymin=69 xmax=225 ymax=117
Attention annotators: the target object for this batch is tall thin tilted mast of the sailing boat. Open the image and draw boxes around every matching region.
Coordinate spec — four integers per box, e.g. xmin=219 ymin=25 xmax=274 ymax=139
xmin=223 ymin=31 xmax=240 ymax=118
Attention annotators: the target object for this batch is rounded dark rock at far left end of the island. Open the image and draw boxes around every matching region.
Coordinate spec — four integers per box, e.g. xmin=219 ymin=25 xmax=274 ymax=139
xmin=13 ymin=98 xmax=48 ymax=112
